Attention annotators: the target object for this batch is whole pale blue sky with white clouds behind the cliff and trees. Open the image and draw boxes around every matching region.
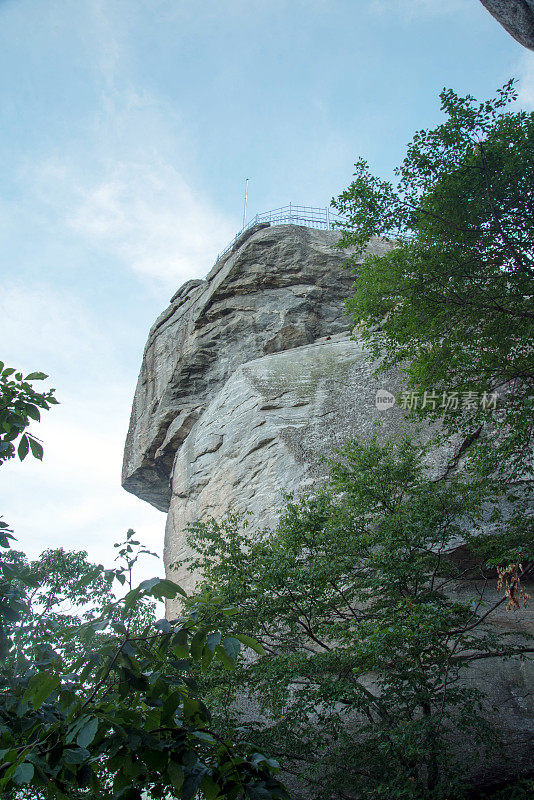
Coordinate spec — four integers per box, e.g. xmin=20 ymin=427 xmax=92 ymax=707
xmin=0 ymin=0 xmax=534 ymax=571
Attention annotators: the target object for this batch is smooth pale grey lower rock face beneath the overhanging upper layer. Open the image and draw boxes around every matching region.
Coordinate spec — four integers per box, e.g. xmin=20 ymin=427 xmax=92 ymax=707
xmin=165 ymin=333 xmax=448 ymax=589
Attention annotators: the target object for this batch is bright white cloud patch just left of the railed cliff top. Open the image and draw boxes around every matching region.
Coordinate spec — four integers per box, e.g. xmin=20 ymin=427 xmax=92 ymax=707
xmin=68 ymin=161 xmax=235 ymax=290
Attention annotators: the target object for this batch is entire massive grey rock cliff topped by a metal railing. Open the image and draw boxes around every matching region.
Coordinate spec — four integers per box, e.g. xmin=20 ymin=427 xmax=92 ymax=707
xmin=123 ymin=225 xmax=534 ymax=788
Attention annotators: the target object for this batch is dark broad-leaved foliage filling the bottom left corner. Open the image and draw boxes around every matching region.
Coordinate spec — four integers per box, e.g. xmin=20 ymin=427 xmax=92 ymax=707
xmin=0 ymin=532 xmax=284 ymax=800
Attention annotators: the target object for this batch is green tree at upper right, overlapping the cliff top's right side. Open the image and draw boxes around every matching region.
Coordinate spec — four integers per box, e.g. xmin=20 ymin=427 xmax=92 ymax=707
xmin=332 ymin=81 xmax=534 ymax=474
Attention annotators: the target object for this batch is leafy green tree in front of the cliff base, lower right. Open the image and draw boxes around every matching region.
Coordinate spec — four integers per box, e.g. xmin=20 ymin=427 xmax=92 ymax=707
xmin=185 ymin=440 xmax=534 ymax=800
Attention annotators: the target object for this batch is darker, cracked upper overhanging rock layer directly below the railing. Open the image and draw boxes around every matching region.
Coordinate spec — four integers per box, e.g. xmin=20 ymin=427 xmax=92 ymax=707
xmin=122 ymin=225 xmax=394 ymax=511
